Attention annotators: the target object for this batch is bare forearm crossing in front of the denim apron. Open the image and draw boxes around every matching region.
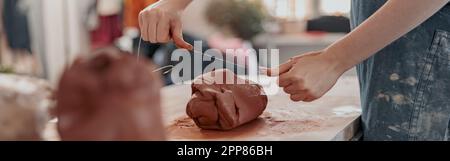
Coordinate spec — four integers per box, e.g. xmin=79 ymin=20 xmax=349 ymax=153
xmin=326 ymin=0 xmax=449 ymax=70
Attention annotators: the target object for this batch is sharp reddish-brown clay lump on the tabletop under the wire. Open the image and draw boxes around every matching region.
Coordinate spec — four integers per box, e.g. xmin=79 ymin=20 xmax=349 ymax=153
xmin=187 ymin=70 xmax=268 ymax=130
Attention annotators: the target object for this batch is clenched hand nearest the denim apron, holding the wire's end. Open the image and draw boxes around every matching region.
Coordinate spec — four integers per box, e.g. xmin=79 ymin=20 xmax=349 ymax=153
xmin=268 ymin=50 xmax=347 ymax=102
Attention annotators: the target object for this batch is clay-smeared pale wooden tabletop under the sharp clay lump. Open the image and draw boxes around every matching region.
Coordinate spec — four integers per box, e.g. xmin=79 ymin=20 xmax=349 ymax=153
xmin=162 ymin=77 xmax=361 ymax=141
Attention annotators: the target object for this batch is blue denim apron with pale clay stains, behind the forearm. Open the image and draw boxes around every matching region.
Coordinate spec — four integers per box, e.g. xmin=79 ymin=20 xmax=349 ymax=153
xmin=351 ymin=0 xmax=450 ymax=141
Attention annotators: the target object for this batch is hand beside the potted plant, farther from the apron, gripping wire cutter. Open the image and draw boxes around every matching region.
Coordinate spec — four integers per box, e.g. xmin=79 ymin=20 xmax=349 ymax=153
xmin=139 ymin=0 xmax=193 ymax=50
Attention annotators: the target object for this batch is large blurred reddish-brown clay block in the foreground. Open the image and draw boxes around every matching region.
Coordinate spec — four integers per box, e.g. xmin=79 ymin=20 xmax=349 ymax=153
xmin=55 ymin=49 xmax=164 ymax=141
